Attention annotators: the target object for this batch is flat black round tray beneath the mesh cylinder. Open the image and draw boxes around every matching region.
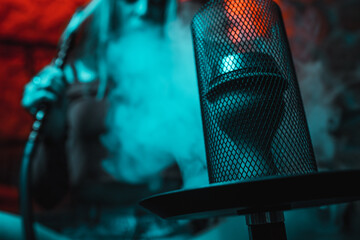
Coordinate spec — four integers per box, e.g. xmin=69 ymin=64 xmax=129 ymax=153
xmin=140 ymin=170 xmax=360 ymax=219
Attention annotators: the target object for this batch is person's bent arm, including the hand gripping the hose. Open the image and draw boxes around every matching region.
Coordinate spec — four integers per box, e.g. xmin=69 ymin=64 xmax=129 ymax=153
xmin=22 ymin=66 xmax=68 ymax=208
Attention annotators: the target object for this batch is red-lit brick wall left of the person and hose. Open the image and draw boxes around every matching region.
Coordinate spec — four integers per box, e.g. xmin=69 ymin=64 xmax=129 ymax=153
xmin=0 ymin=0 xmax=88 ymax=211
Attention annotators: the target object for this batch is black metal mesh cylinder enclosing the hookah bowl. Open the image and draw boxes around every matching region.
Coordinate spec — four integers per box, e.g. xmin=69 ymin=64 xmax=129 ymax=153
xmin=191 ymin=0 xmax=317 ymax=183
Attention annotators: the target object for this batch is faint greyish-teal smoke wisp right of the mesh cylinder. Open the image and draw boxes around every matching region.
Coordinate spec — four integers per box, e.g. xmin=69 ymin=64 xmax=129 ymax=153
xmin=298 ymin=60 xmax=340 ymax=163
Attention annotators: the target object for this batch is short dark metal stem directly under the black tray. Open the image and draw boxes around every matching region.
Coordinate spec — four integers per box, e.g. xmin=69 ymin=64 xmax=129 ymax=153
xmin=246 ymin=211 xmax=287 ymax=240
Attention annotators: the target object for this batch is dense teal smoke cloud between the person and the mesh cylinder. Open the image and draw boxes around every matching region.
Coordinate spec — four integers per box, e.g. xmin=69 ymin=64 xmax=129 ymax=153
xmin=103 ymin=16 xmax=208 ymax=187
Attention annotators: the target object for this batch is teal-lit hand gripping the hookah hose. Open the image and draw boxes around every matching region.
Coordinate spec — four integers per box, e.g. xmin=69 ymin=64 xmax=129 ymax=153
xmin=21 ymin=65 xmax=65 ymax=114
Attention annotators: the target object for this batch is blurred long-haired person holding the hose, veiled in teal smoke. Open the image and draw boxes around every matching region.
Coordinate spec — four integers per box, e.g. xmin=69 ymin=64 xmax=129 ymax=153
xmin=22 ymin=0 xmax=214 ymax=239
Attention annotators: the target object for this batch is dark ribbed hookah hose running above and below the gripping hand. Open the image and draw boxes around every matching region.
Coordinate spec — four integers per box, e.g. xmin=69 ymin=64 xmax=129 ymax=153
xmin=19 ymin=0 xmax=103 ymax=240
